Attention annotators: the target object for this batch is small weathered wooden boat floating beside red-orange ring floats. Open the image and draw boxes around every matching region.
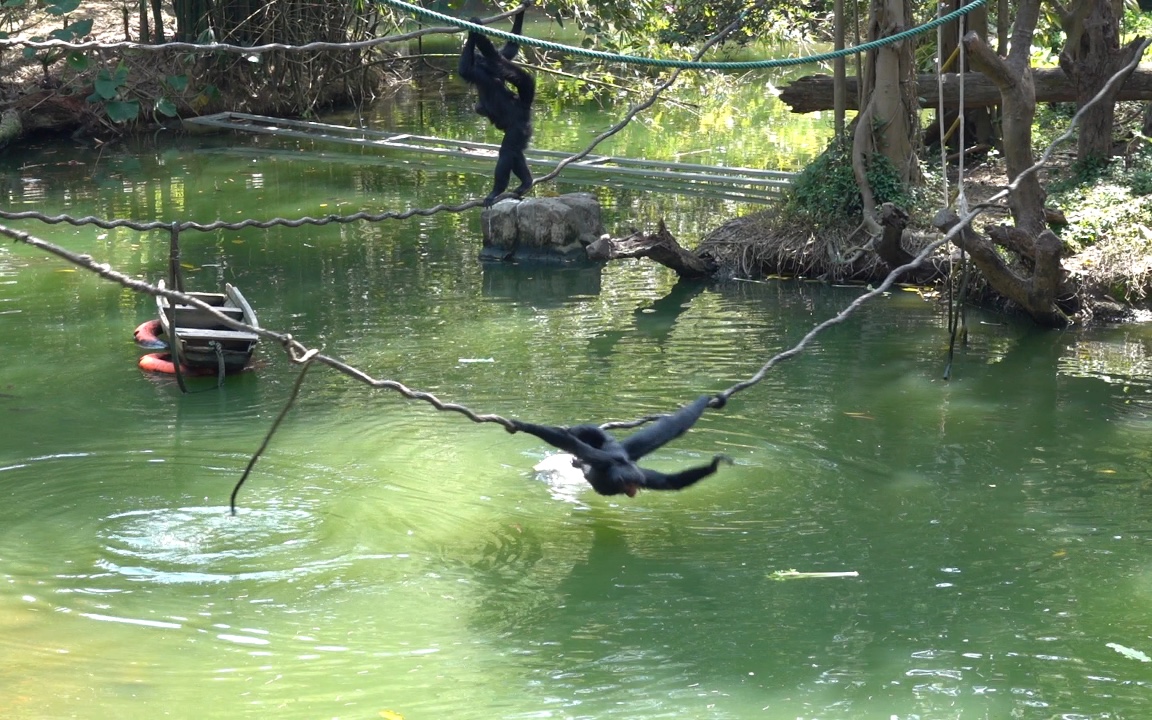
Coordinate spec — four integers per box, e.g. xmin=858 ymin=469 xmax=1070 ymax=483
xmin=156 ymin=280 xmax=260 ymax=373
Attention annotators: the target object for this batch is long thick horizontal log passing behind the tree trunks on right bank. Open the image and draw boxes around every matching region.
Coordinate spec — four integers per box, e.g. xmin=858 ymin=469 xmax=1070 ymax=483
xmin=780 ymin=68 xmax=1152 ymax=113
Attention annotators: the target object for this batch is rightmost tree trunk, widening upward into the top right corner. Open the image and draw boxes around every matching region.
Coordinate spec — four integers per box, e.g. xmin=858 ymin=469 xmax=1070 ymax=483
xmin=1056 ymin=0 xmax=1143 ymax=161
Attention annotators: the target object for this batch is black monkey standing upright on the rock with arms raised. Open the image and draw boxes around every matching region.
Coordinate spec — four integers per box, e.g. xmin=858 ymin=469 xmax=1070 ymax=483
xmin=458 ymin=10 xmax=536 ymax=206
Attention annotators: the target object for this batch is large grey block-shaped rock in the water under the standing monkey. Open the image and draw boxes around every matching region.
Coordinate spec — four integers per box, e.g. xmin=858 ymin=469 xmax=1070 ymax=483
xmin=480 ymin=192 xmax=604 ymax=262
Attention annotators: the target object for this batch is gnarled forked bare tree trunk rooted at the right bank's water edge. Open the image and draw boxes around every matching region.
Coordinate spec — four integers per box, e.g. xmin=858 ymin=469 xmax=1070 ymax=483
xmin=937 ymin=0 xmax=1067 ymax=326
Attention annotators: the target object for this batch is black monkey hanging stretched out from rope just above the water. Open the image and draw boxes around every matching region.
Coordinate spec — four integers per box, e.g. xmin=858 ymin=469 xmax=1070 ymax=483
xmin=511 ymin=395 xmax=732 ymax=498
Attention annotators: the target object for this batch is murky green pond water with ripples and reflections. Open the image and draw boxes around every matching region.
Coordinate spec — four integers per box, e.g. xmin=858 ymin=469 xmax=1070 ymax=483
xmin=0 ymin=71 xmax=1152 ymax=720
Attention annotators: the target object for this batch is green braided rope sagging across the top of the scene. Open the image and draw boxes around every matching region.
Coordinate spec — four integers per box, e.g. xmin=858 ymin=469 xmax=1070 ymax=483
xmin=378 ymin=0 xmax=987 ymax=70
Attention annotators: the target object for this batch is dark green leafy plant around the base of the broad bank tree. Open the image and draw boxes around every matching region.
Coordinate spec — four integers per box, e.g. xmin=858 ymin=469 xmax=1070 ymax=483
xmin=783 ymin=139 xmax=911 ymax=228
